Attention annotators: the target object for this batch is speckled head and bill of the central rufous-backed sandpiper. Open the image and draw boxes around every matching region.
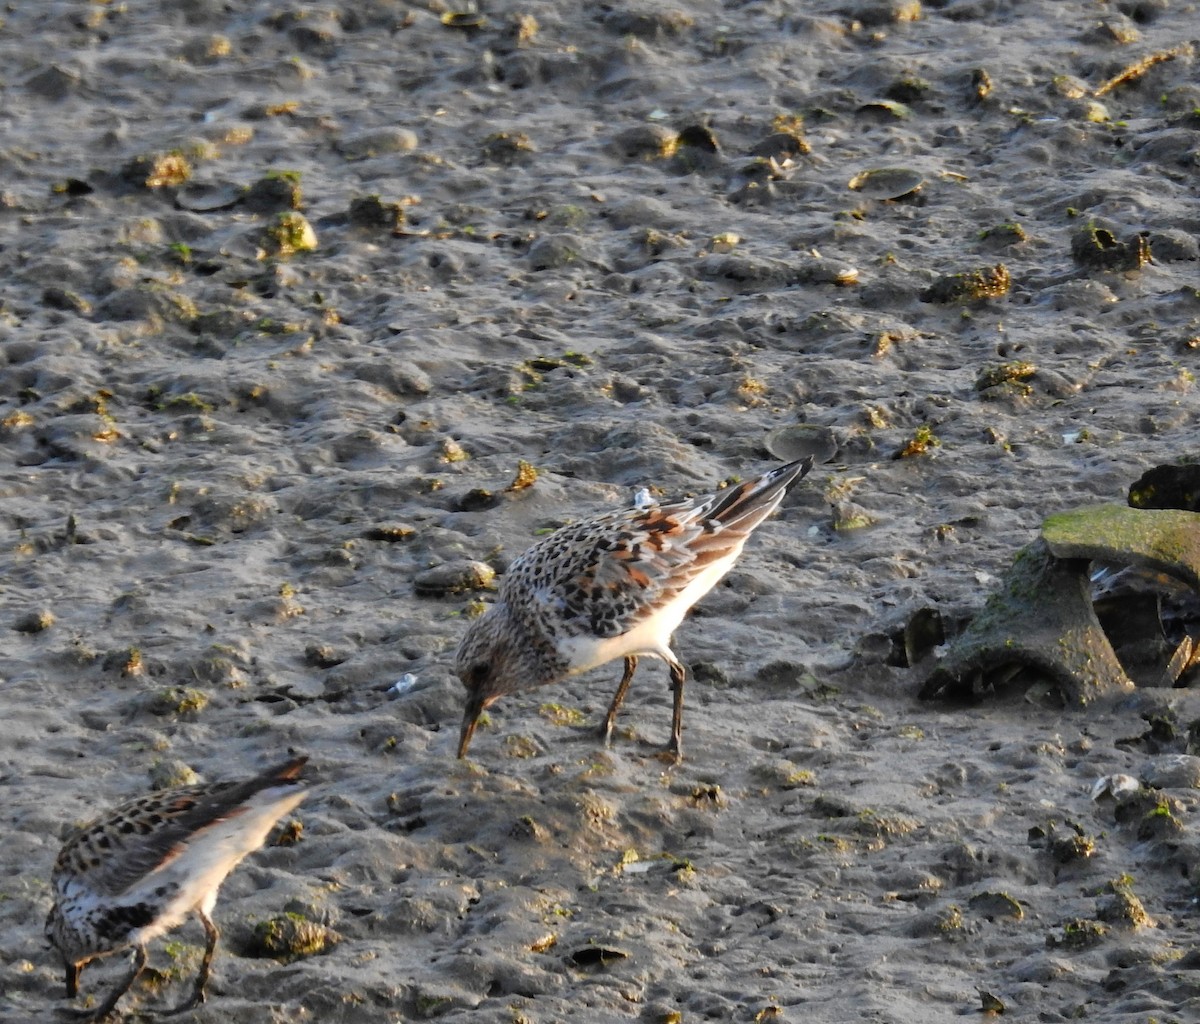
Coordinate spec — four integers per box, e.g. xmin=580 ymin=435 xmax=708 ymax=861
xmin=455 ymin=601 xmax=553 ymax=757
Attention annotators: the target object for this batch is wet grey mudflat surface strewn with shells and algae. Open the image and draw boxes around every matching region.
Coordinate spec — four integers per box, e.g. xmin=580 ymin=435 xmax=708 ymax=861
xmin=0 ymin=0 xmax=1200 ymax=1024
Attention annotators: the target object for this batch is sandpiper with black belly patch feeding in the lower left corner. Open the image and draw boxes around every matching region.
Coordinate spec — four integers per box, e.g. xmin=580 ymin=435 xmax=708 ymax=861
xmin=46 ymin=757 xmax=308 ymax=1020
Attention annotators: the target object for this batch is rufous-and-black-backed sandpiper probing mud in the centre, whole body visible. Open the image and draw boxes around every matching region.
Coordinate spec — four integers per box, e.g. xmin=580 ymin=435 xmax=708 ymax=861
xmin=455 ymin=456 xmax=812 ymax=761
